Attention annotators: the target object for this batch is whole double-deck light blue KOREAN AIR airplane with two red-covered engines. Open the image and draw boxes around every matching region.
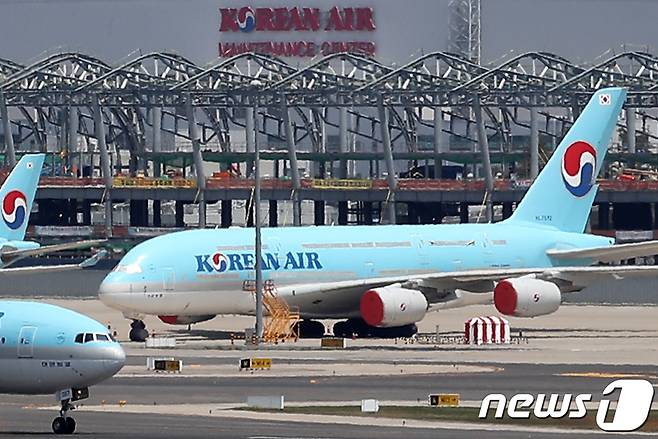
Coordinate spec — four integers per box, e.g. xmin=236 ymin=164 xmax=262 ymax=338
xmin=99 ymin=88 xmax=658 ymax=340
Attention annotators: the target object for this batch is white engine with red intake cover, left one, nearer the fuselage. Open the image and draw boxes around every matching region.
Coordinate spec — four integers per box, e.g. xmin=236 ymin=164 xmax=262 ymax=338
xmin=360 ymin=285 xmax=427 ymax=328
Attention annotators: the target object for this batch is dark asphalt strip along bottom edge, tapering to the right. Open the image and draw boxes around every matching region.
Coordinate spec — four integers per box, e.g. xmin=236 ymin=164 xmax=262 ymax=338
xmin=0 ymin=405 xmax=646 ymax=439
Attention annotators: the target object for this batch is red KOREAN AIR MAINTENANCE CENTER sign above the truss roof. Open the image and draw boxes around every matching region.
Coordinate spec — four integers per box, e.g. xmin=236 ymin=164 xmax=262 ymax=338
xmin=219 ymin=6 xmax=376 ymax=57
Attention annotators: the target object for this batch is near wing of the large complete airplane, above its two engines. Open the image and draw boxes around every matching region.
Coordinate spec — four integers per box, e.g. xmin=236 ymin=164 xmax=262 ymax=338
xmin=278 ymin=265 xmax=658 ymax=318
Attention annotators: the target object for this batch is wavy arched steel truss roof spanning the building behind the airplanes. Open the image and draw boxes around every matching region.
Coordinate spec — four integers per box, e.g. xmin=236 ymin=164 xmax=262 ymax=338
xmin=0 ymin=52 xmax=658 ymax=107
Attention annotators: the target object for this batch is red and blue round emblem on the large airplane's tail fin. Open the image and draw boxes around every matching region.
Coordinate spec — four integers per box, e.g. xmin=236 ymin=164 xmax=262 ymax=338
xmin=562 ymin=140 xmax=596 ymax=197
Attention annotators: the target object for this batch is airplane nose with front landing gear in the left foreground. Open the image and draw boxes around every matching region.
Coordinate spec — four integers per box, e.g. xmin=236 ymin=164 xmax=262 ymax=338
xmin=0 ymin=300 xmax=126 ymax=434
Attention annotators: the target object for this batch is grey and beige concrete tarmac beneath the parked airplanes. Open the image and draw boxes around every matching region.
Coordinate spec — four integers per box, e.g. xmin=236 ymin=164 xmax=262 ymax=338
xmin=0 ymin=279 xmax=658 ymax=439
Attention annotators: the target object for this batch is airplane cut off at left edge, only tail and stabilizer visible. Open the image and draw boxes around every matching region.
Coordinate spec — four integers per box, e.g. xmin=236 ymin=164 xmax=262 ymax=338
xmin=0 ymin=154 xmax=102 ymax=273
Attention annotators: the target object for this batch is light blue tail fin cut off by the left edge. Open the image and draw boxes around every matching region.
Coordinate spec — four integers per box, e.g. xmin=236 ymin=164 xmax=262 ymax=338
xmin=0 ymin=154 xmax=45 ymax=241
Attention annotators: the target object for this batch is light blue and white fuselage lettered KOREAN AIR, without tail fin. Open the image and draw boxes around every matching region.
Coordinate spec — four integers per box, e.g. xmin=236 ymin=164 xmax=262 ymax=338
xmin=100 ymin=222 xmax=614 ymax=318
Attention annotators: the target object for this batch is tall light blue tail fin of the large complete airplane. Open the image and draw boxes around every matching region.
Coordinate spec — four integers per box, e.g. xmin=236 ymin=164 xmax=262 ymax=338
xmin=507 ymin=88 xmax=626 ymax=233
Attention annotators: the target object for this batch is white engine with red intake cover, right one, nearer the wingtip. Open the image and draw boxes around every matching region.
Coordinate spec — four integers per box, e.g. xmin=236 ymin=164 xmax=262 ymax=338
xmin=494 ymin=277 xmax=562 ymax=317
